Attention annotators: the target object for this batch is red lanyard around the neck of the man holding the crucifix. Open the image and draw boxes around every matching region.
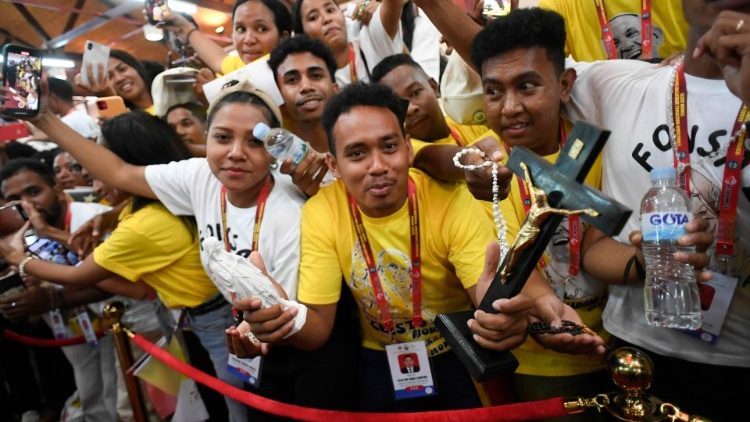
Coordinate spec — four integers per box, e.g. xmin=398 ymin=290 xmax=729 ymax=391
xmin=349 ymin=177 xmax=422 ymax=332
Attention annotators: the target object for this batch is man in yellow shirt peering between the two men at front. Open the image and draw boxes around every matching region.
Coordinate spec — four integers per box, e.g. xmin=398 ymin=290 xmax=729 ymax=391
xmin=371 ymin=54 xmax=488 ymax=180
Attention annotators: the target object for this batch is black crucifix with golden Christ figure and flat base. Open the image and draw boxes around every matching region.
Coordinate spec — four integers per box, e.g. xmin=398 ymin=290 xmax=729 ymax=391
xmin=435 ymin=122 xmax=631 ymax=381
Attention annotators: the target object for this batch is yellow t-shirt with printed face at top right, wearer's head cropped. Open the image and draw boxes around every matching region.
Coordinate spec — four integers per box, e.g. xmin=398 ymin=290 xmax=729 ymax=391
xmin=539 ymin=0 xmax=688 ymax=62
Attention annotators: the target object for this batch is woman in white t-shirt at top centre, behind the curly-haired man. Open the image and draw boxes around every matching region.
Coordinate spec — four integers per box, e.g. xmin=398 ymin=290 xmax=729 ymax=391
xmin=292 ymin=0 xmax=404 ymax=88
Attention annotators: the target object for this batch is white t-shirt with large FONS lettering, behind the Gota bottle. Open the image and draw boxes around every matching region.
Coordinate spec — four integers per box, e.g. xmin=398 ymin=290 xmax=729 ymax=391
xmin=565 ymin=60 xmax=750 ymax=367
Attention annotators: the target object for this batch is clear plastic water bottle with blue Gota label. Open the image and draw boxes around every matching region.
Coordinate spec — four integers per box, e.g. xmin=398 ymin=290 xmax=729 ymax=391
xmin=641 ymin=167 xmax=701 ymax=330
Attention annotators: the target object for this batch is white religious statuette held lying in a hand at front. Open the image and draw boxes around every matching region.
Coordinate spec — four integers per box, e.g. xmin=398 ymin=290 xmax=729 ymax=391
xmin=203 ymin=237 xmax=307 ymax=338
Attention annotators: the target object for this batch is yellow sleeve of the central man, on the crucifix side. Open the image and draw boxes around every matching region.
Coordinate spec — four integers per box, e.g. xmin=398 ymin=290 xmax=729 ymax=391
xmin=443 ymin=185 xmax=497 ymax=289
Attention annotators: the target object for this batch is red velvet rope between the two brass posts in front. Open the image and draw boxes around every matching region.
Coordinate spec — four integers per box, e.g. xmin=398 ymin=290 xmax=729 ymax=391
xmin=133 ymin=334 xmax=567 ymax=422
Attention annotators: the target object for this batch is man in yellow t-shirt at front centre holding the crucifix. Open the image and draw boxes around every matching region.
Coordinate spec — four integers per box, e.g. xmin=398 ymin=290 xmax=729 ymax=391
xmin=235 ymin=84 xmax=600 ymax=411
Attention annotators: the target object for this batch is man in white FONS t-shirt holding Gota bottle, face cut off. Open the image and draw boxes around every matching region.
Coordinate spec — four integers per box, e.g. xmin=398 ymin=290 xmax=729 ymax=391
xmin=565 ymin=0 xmax=750 ymax=420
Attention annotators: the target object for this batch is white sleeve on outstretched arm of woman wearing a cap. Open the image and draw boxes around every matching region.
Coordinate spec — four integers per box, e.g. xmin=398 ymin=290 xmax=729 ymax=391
xmin=146 ymin=158 xmax=203 ymax=215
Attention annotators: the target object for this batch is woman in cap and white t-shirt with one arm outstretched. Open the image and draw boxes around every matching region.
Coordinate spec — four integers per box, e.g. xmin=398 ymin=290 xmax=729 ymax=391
xmin=2 ymin=75 xmax=356 ymax=420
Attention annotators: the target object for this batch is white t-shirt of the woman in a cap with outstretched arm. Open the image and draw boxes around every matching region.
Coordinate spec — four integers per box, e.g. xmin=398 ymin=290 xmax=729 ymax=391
xmin=146 ymin=158 xmax=305 ymax=300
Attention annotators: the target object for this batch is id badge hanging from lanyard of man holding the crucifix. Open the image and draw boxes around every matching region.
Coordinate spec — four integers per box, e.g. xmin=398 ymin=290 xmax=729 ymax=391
xmin=385 ymin=341 xmax=437 ymax=400
